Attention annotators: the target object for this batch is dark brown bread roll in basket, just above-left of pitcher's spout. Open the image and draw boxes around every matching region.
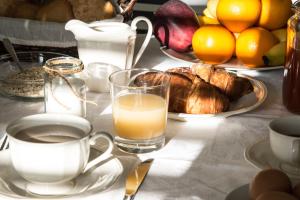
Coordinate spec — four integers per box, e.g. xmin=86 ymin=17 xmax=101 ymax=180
xmin=36 ymin=0 xmax=74 ymax=22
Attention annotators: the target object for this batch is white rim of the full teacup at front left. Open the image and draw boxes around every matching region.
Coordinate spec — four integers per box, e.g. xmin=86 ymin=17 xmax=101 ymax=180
xmin=5 ymin=113 xmax=93 ymax=146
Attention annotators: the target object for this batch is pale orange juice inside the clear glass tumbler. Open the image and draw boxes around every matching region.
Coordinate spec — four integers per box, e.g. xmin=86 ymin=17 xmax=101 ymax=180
xmin=113 ymin=93 xmax=168 ymax=140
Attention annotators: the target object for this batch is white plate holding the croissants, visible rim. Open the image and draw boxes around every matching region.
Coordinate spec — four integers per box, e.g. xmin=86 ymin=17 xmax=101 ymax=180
xmin=168 ymin=74 xmax=267 ymax=121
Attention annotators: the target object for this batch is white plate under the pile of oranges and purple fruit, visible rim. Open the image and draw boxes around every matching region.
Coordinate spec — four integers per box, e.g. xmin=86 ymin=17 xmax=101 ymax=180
xmin=160 ymin=47 xmax=283 ymax=71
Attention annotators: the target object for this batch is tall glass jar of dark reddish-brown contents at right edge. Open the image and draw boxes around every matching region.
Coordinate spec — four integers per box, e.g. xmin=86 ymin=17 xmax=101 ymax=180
xmin=282 ymin=3 xmax=300 ymax=113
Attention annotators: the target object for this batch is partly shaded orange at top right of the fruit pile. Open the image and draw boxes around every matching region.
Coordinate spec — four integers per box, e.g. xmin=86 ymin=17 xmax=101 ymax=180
xmin=258 ymin=0 xmax=292 ymax=30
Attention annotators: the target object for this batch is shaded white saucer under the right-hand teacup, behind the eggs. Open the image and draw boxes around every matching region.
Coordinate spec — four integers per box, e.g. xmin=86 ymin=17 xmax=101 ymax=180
xmin=244 ymin=138 xmax=300 ymax=179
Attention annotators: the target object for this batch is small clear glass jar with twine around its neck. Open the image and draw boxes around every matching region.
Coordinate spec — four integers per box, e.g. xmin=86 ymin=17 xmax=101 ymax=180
xmin=44 ymin=57 xmax=86 ymax=117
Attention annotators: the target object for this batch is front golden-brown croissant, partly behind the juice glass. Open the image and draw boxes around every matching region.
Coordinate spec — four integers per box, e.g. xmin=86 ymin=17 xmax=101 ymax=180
xmin=134 ymin=72 xmax=229 ymax=114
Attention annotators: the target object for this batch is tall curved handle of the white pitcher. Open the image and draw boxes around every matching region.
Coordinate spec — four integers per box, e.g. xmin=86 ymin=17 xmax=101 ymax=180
xmin=131 ymin=16 xmax=153 ymax=66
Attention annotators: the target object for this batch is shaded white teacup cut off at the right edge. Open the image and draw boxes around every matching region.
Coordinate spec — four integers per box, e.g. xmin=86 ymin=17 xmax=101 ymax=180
xmin=269 ymin=116 xmax=300 ymax=171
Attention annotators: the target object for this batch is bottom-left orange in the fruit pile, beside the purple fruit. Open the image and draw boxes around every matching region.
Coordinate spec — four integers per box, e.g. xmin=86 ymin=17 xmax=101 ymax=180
xmin=192 ymin=25 xmax=235 ymax=64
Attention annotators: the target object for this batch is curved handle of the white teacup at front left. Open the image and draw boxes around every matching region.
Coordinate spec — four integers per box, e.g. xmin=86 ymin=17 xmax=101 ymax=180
xmin=83 ymin=131 xmax=114 ymax=173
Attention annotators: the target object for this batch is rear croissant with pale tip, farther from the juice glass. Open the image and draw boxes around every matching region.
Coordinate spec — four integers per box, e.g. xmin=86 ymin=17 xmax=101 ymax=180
xmin=192 ymin=64 xmax=253 ymax=101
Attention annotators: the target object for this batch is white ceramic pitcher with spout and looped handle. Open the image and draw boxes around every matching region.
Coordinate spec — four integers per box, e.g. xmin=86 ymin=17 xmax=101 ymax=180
xmin=65 ymin=17 xmax=153 ymax=69
